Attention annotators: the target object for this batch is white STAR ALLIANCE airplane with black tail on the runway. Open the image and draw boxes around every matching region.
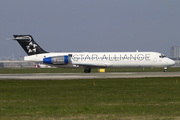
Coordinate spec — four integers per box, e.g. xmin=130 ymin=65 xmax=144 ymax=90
xmin=13 ymin=35 xmax=175 ymax=73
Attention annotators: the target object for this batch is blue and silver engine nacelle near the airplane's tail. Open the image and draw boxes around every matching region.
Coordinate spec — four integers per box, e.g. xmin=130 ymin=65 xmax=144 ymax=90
xmin=43 ymin=55 xmax=69 ymax=65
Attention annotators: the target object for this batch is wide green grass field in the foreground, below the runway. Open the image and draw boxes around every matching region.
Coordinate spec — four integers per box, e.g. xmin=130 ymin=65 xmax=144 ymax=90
xmin=0 ymin=77 xmax=180 ymax=120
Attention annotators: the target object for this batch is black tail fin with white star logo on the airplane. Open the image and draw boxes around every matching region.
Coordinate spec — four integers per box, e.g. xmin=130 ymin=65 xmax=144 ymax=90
xmin=13 ymin=35 xmax=48 ymax=55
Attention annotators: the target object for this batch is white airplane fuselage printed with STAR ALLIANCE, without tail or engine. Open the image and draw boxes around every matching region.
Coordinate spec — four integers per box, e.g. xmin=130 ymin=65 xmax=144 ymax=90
xmin=24 ymin=52 xmax=175 ymax=68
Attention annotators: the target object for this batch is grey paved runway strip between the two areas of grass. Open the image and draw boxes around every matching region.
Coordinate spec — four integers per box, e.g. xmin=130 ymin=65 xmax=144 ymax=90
xmin=0 ymin=72 xmax=180 ymax=80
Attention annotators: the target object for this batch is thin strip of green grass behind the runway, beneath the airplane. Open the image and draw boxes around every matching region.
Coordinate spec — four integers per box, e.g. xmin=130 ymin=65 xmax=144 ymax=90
xmin=0 ymin=67 xmax=180 ymax=74
